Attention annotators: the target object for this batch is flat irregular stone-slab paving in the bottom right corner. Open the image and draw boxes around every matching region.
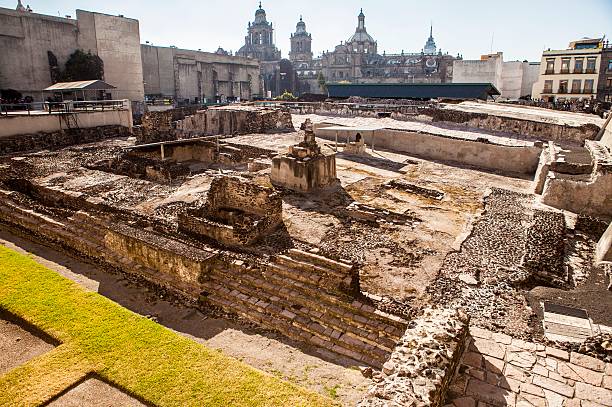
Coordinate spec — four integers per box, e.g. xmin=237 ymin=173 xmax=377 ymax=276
xmin=451 ymin=327 xmax=612 ymax=407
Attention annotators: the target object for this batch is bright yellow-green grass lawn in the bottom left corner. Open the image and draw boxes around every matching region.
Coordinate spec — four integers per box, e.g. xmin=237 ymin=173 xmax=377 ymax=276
xmin=0 ymin=246 xmax=334 ymax=406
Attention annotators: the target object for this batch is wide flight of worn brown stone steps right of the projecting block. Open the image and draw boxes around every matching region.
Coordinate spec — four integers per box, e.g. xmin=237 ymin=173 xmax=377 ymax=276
xmin=203 ymin=250 xmax=407 ymax=367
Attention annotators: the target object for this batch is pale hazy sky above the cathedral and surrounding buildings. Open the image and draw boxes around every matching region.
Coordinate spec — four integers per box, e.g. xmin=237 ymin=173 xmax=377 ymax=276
xmin=0 ymin=0 xmax=612 ymax=61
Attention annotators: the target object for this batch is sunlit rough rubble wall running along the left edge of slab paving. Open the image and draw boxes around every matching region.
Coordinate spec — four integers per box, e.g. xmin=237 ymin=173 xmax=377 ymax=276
xmin=357 ymin=308 xmax=469 ymax=407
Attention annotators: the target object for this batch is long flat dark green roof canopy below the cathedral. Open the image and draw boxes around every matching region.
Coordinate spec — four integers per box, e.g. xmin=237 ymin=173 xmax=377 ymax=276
xmin=326 ymin=83 xmax=500 ymax=100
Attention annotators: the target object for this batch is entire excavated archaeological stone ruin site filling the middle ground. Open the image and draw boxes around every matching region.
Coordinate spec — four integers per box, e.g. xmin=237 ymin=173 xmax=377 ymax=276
xmin=0 ymin=102 xmax=612 ymax=407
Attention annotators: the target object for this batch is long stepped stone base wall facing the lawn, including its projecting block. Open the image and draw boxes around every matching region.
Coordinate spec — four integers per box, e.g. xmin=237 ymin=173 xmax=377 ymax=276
xmin=0 ymin=191 xmax=407 ymax=367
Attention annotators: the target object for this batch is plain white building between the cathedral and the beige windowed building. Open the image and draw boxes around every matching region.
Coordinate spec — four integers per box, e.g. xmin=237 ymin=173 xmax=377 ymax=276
xmin=453 ymin=52 xmax=540 ymax=100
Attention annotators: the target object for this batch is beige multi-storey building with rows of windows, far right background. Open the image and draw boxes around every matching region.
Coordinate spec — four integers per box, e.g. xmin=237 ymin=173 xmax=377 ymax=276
xmin=532 ymin=38 xmax=605 ymax=101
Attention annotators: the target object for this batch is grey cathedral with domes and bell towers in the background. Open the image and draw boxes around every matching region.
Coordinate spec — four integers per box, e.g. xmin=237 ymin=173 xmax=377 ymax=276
xmin=237 ymin=3 xmax=461 ymax=96
